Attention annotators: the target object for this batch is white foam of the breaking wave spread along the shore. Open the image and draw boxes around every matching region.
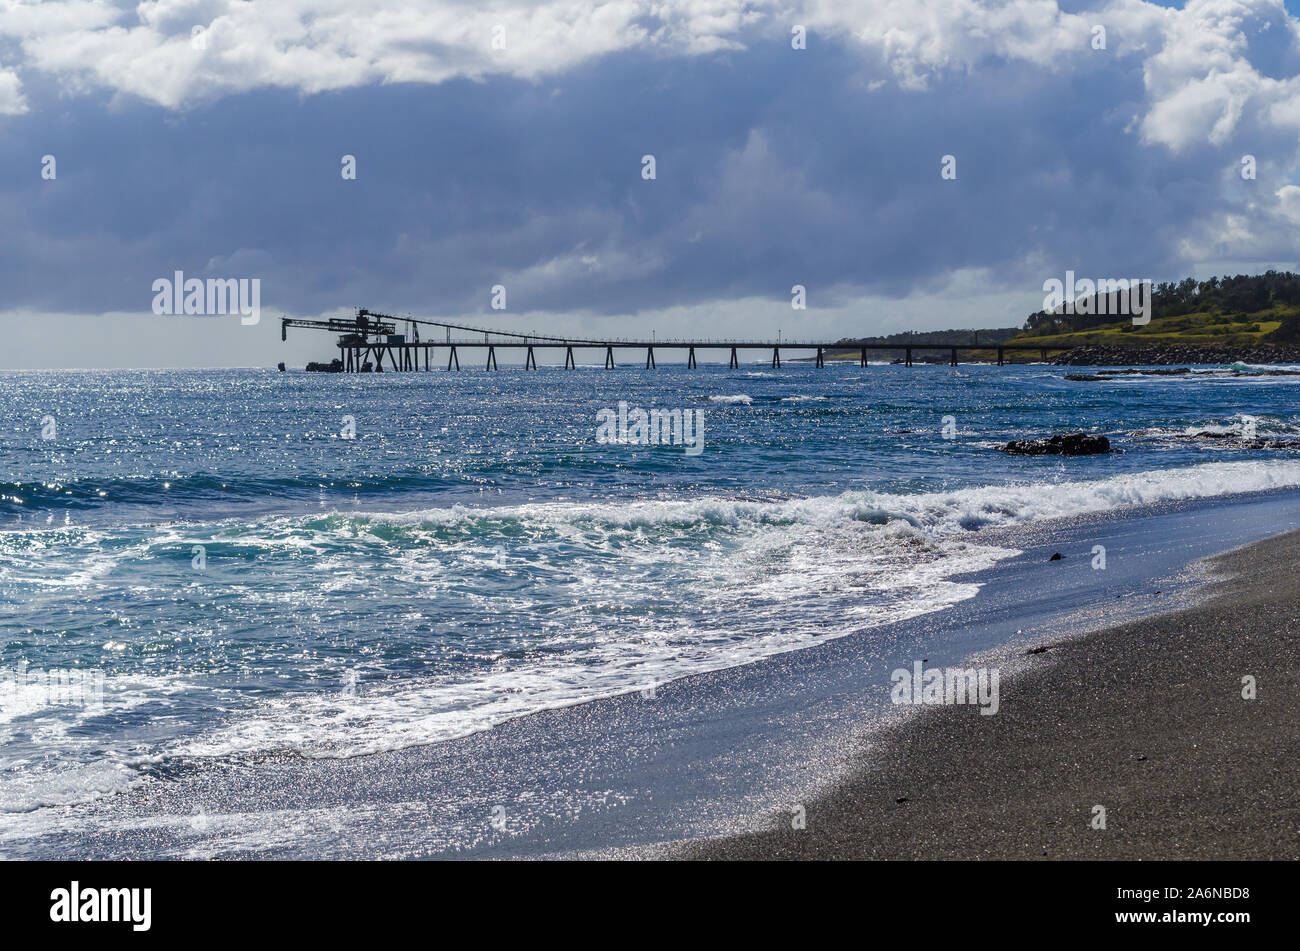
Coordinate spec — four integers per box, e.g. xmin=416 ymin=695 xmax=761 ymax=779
xmin=0 ymin=460 xmax=1300 ymax=831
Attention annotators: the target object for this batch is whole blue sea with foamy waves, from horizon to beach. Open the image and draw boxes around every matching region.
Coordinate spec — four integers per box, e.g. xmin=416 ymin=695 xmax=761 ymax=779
xmin=0 ymin=364 xmax=1300 ymax=835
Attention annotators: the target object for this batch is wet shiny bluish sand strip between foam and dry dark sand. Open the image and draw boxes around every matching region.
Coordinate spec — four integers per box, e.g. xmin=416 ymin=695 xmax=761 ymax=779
xmin=10 ymin=490 xmax=1300 ymax=859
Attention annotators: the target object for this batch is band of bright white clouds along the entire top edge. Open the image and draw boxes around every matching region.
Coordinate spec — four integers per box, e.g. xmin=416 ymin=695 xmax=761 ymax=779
xmin=0 ymin=0 xmax=1300 ymax=163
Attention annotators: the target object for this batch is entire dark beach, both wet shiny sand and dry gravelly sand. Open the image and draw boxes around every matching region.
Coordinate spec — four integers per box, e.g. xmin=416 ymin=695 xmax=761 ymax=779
xmin=0 ymin=491 xmax=1300 ymax=859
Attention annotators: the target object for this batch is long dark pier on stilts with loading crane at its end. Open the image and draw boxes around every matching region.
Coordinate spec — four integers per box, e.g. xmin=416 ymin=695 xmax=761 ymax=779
xmin=280 ymin=308 xmax=1070 ymax=373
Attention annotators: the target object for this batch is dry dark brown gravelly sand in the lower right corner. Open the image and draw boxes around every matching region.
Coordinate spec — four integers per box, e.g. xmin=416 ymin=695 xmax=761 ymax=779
xmin=683 ymin=533 xmax=1300 ymax=859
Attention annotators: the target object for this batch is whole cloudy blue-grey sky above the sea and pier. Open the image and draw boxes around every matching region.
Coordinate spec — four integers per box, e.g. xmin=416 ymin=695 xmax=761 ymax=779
xmin=0 ymin=0 xmax=1300 ymax=369
